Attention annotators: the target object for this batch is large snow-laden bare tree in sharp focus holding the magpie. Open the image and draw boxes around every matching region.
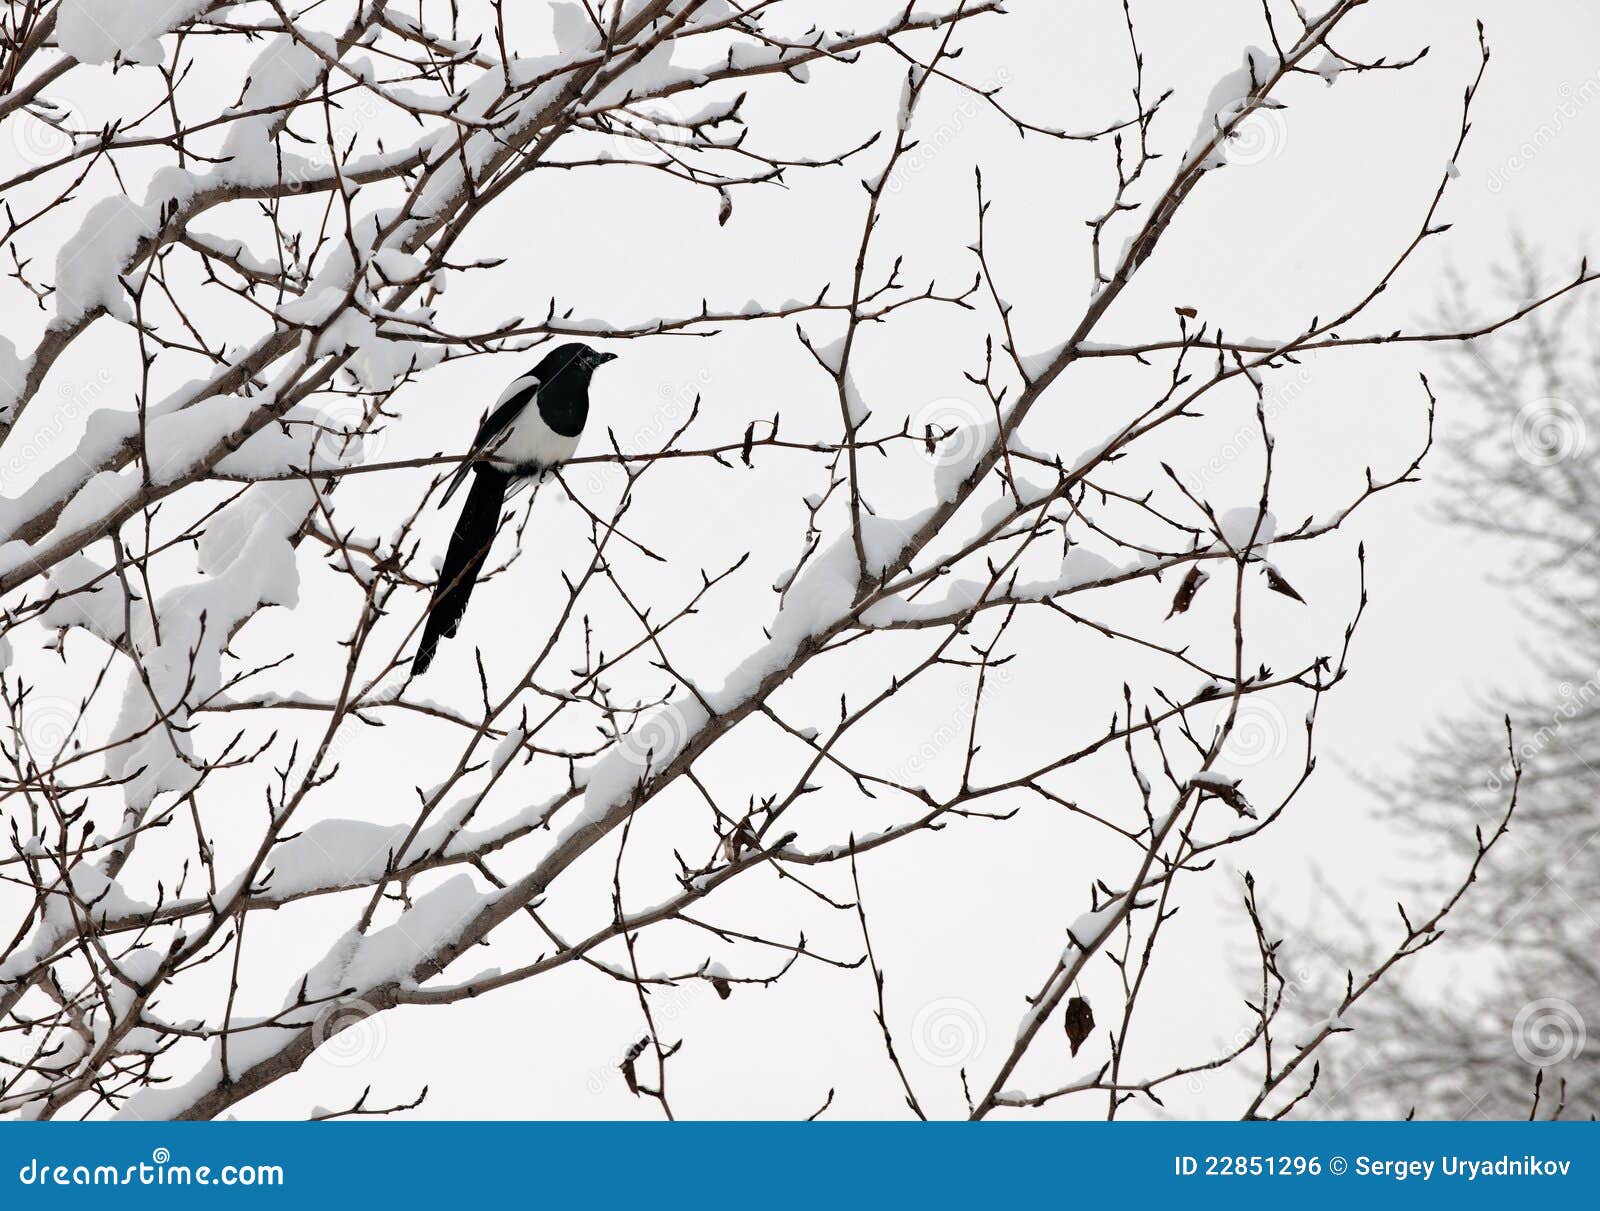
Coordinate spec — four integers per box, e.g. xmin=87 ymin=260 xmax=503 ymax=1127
xmin=0 ymin=0 xmax=1592 ymax=1118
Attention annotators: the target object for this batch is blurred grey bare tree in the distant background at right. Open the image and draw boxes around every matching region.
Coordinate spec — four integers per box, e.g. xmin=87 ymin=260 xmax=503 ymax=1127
xmin=1330 ymin=248 xmax=1600 ymax=1118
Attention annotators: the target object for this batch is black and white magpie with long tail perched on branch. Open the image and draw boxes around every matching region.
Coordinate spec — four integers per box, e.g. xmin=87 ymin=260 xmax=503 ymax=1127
xmin=411 ymin=344 xmax=616 ymax=677
